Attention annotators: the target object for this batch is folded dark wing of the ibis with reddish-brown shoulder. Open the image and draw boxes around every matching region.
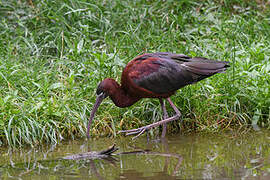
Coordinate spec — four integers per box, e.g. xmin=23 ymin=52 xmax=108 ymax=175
xmin=132 ymin=53 xmax=227 ymax=94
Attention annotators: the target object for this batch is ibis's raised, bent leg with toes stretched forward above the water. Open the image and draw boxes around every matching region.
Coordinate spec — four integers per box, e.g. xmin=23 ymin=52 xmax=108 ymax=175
xmin=119 ymin=98 xmax=181 ymax=139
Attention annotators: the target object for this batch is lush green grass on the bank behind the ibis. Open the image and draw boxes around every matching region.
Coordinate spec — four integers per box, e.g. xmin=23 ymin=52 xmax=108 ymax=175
xmin=0 ymin=0 xmax=270 ymax=146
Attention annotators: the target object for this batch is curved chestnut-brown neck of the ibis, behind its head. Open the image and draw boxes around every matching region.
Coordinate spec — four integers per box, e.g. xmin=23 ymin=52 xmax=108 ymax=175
xmin=109 ymin=81 xmax=141 ymax=108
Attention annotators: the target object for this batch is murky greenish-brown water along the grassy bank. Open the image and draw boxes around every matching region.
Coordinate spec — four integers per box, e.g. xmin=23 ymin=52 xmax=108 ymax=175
xmin=0 ymin=131 xmax=270 ymax=180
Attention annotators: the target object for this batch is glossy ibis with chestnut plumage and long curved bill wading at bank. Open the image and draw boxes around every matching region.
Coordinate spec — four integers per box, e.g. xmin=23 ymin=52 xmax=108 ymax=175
xmin=87 ymin=52 xmax=229 ymax=138
